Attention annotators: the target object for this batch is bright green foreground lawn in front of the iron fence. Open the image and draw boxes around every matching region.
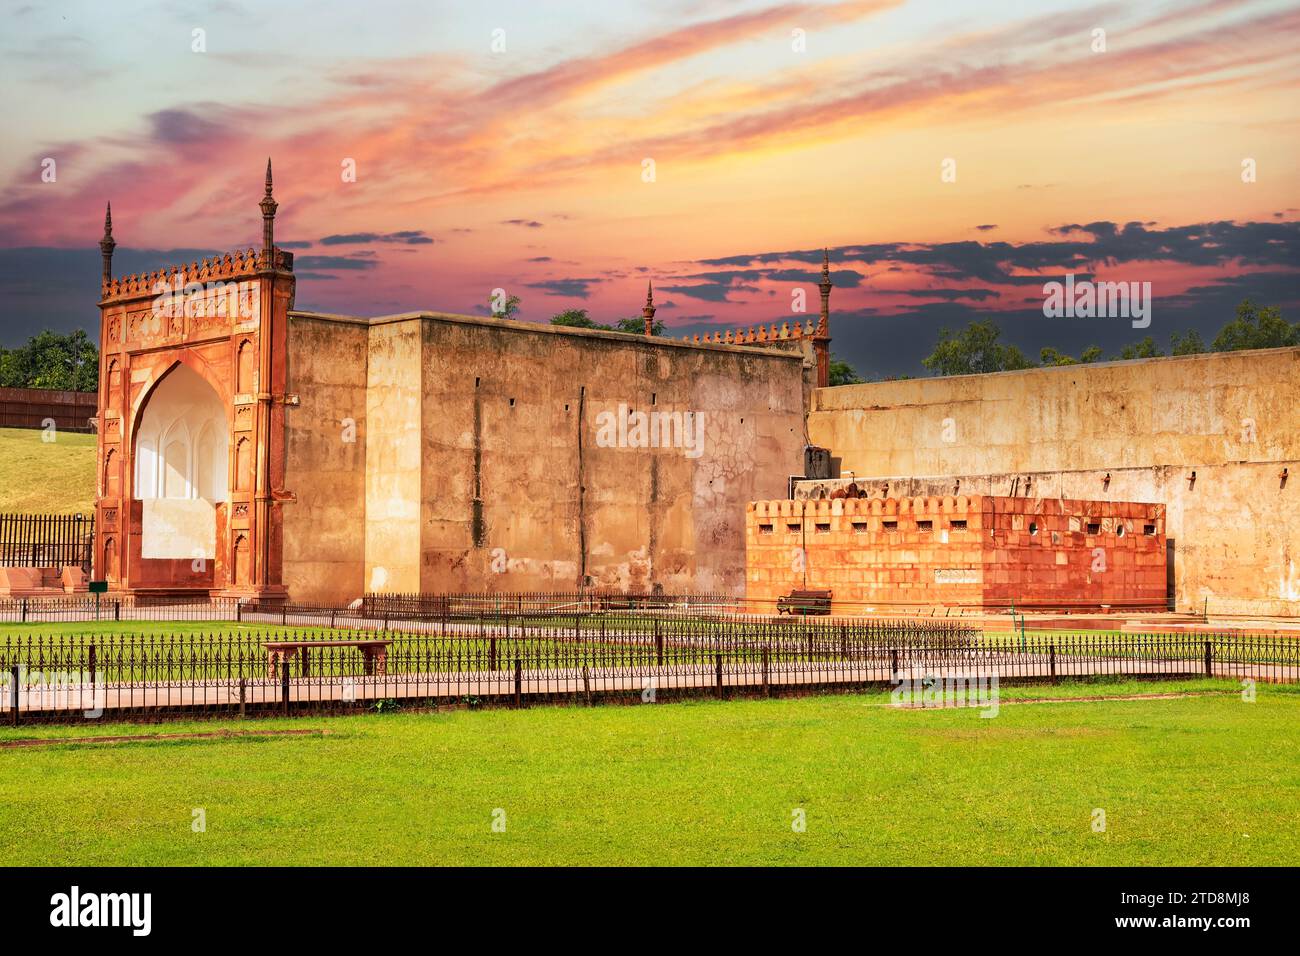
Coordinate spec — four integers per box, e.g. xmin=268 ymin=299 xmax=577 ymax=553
xmin=0 ymin=682 xmax=1300 ymax=865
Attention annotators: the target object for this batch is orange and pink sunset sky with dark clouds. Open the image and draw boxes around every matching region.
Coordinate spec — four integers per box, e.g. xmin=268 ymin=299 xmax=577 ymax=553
xmin=0 ymin=0 xmax=1300 ymax=377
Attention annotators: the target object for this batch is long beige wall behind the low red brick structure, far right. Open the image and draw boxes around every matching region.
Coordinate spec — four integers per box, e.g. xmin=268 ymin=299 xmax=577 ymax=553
xmin=801 ymin=349 xmax=1300 ymax=615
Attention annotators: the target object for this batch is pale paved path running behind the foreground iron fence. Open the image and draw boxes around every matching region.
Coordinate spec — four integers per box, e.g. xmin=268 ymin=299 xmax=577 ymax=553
xmin=0 ymin=654 xmax=1300 ymax=714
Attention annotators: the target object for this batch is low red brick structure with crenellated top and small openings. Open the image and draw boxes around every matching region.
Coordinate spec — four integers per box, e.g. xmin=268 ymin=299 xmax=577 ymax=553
xmin=745 ymin=496 xmax=1167 ymax=614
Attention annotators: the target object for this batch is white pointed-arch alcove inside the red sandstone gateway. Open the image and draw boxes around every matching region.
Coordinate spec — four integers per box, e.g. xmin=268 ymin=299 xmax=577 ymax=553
xmin=134 ymin=364 xmax=230 ymax=559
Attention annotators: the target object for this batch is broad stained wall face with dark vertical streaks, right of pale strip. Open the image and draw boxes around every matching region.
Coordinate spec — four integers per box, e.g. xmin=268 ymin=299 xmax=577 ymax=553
xmin=410 ymin=316 xmax=805 ymax=593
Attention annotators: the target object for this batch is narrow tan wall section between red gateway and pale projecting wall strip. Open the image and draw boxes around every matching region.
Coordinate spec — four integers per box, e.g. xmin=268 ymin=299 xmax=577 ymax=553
xmin=281 ymin=313 xmax=369 ymax=601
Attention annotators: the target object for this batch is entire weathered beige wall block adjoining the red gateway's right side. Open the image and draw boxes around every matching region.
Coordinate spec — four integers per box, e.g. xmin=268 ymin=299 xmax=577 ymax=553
xmin=285 ymin=313 xmax=813 ymax=601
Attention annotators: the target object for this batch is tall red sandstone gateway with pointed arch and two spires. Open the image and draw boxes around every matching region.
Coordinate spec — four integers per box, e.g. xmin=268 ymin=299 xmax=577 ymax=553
xmin=94 ymin=160 xmax=294 ymax=600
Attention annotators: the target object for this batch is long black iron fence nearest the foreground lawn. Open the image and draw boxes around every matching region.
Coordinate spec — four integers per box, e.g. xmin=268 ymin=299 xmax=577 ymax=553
xmin=0 ymin=619 xmax=1300 ymax=722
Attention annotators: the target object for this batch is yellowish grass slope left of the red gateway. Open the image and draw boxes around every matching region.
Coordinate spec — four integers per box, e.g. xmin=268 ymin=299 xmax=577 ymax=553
xmin=0 ymin=428 xmax=95 ymax=515
